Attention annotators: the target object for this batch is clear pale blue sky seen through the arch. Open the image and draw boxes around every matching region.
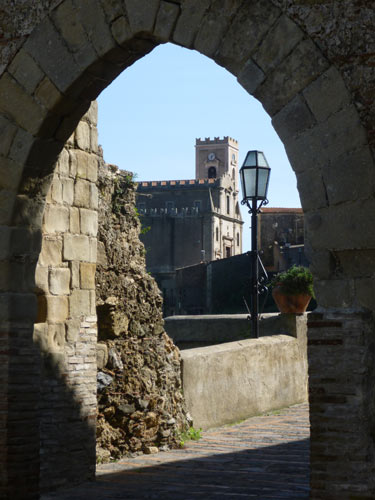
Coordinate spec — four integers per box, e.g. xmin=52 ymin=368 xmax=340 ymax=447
xmin=98 ymin=44 xmax=301 ymax=251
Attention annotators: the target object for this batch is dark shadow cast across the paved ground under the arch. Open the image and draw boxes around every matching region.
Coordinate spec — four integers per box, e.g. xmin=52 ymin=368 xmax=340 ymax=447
xmin=43 ymin=439 xmax=309 ymax=500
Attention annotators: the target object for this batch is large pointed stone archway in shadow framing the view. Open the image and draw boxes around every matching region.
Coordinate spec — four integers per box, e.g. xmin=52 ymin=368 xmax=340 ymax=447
xmin=0 ymin=0 xmax=375 ymax=498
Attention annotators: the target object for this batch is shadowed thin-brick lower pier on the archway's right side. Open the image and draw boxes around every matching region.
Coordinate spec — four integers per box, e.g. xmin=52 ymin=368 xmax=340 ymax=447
xmin=308 ymin=312 xmax=375 ymax=500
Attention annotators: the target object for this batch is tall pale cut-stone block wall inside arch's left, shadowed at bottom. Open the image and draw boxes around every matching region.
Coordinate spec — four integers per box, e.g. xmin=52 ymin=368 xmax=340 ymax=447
xmin=34 ymin=102 xmax=99 ymax=491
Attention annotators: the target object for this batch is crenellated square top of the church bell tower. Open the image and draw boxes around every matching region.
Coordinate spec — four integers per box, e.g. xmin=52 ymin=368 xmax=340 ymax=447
xmin=195 ymin=136 xmax=238 ymax=189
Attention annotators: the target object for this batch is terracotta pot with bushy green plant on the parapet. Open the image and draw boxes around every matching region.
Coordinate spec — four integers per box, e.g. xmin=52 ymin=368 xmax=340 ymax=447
xmin=271 ymin=266 xmax=315 ymax=314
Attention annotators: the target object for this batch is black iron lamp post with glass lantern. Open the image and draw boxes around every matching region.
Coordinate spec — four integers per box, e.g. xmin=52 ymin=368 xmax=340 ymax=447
xmin=240 ymin=151 xmax=271 ymax=338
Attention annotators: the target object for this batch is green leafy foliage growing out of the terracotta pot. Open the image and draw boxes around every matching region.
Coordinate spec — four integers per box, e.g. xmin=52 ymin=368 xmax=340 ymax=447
xmin=271 ymin=266 xmax=315 ymax=298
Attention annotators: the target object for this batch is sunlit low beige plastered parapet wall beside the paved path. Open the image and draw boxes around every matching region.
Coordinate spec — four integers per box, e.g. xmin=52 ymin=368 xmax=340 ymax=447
xmin=181 ymin=315 xmax=307 ymax=429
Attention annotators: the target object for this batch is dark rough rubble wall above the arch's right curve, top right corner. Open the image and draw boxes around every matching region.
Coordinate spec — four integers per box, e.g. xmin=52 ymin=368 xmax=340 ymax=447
xmin=272 ymin=0 xmax=375 ymax=152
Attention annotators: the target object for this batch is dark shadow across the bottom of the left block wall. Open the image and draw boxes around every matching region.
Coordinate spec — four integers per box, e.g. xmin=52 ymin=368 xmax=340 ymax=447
xmin=32 ymin=334 xmax=96 ymax=498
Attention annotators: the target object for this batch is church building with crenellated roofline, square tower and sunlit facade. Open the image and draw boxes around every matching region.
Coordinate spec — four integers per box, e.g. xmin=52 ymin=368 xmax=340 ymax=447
xmin=137 ymin=137 xmax=243 ymax=273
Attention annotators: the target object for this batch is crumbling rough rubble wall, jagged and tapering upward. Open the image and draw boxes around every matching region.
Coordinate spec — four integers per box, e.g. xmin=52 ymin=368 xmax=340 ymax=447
xmin=96 ymin=162 xmax=186 ymax=461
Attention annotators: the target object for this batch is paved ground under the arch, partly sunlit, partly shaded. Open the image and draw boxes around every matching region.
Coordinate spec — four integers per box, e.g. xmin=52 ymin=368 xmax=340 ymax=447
xmin=42 ymin=405 xmax=309 ymax=500
